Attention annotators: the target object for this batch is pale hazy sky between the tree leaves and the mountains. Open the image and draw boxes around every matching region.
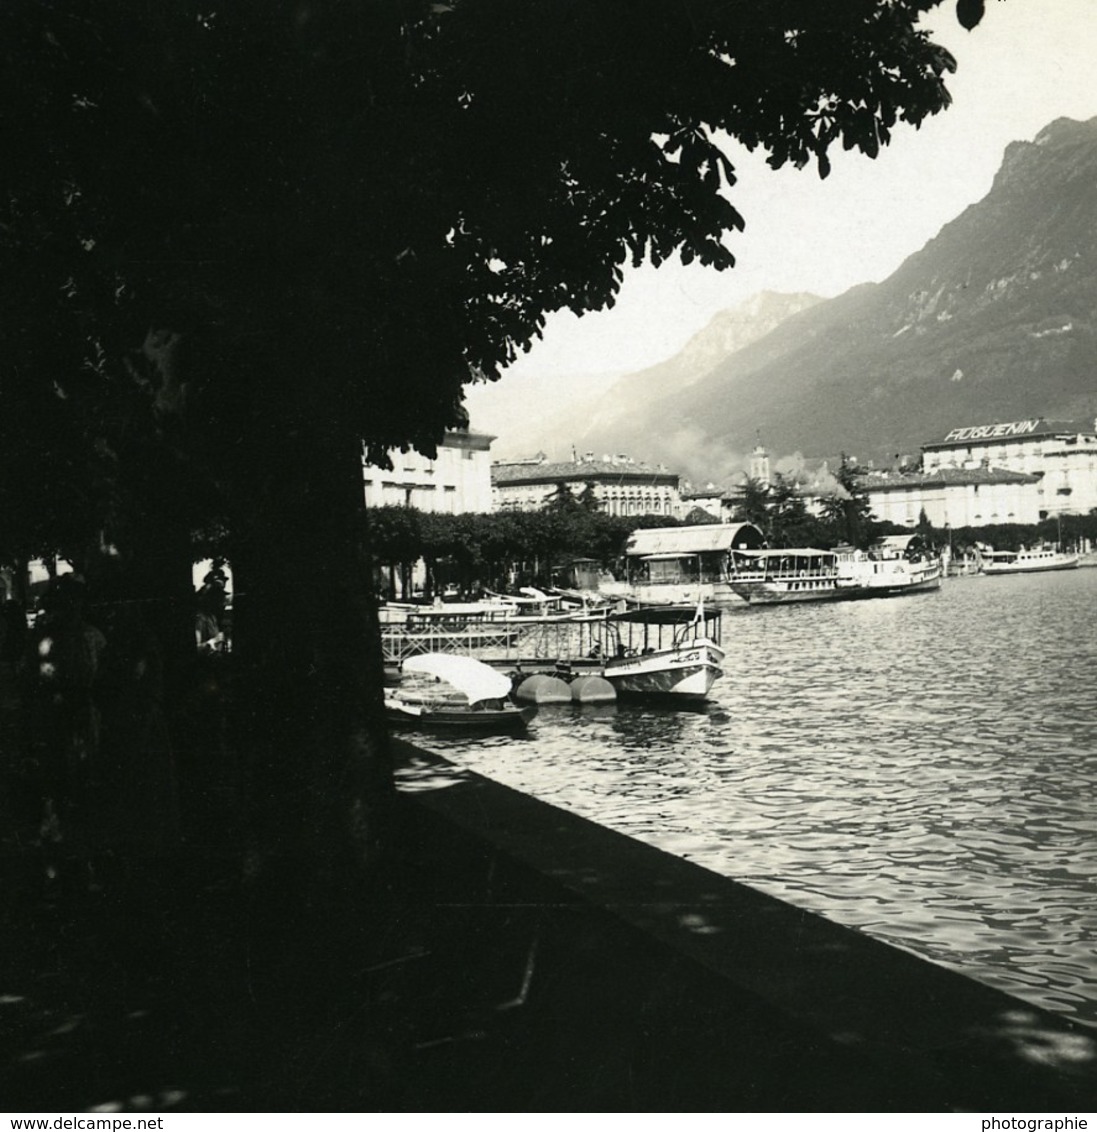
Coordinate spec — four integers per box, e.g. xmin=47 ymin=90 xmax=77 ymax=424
xmin=469 ymin=0 xmax=1097 ymax=439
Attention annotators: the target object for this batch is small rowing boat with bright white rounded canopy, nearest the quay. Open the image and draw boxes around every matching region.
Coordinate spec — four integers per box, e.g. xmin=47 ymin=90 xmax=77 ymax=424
xmin=385 ymin=653 xmax=534 ymax=731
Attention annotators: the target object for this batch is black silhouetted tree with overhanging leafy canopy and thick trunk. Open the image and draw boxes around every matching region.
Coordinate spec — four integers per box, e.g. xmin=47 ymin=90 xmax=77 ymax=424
xmin=0 ymin=0 xmax=969 ymax=869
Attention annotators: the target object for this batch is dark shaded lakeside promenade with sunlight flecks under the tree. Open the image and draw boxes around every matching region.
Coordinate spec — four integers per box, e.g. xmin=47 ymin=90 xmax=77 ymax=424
xmin=0 ymin=744 xmax=1097 ymax=1113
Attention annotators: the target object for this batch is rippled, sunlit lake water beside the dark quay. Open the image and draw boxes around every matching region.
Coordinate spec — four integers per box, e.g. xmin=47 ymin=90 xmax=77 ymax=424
xmin=393 ymin=569 xmax=1097 ymax=1026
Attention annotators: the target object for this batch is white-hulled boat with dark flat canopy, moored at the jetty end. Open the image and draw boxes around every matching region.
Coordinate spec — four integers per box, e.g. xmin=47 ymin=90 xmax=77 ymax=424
xmin=577 ymin=604 xmax=725 ymax=702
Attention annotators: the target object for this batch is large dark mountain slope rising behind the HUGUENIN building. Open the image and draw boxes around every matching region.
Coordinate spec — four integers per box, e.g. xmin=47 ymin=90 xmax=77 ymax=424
xmin=568 ymin=119 xmax=1097 ymax=475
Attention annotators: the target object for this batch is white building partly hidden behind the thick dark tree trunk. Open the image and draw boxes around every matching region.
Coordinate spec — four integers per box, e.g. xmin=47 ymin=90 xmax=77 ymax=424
xmin=362 ymin=429 xmax=495 ymax=515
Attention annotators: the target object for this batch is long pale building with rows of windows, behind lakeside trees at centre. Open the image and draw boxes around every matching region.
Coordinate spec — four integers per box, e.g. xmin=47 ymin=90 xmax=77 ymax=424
xmin=491 ymin=453 xmax=679 ymax=516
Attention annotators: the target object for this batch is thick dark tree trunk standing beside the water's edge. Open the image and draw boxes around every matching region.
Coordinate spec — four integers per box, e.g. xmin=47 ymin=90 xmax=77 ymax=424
xmin=233 ymin=425 xmax=393 ymax=891
